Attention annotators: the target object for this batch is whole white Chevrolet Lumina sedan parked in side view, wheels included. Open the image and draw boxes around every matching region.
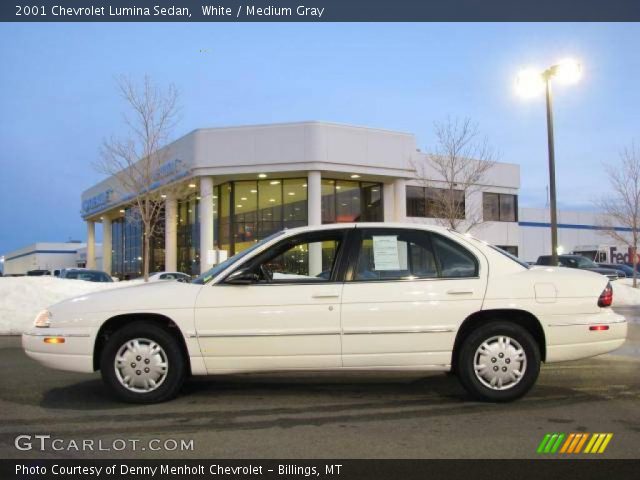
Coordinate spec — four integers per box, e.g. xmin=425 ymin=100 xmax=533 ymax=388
xmin=22 ymin=223 xmax=627 ymax=403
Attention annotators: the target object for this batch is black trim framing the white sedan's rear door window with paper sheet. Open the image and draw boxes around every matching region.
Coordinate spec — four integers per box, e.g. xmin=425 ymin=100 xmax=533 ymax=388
xmin=344 ymin=227 xmax=481 ymax=284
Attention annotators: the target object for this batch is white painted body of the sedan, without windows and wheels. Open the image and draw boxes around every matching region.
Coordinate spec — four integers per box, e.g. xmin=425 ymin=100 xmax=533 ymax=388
xmin=22 ymin=223 xmax=627 ymax=402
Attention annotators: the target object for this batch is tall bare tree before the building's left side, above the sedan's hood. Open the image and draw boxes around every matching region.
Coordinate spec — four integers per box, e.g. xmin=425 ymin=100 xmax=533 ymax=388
xmin=95 ymin=75 xmax=178 ymax=281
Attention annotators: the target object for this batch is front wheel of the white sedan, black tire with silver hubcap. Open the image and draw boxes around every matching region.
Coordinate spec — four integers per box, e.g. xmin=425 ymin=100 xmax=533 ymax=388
xmin=100 ymin=321 xmax=186 ymax=403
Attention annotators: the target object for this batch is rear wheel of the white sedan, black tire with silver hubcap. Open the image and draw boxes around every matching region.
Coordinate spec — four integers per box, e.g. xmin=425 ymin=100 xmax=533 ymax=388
xmin=456 ymin=321 xmax=540 ymax=402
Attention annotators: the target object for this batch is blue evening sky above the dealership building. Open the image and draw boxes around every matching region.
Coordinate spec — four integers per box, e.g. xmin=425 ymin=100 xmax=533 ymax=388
xmin=0 ymin=23 xmax=640 ymax=254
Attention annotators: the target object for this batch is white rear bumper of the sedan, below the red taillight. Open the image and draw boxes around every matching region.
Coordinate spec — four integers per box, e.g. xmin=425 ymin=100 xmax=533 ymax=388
xmin=542 ymin=308 xmax=627 ymax=363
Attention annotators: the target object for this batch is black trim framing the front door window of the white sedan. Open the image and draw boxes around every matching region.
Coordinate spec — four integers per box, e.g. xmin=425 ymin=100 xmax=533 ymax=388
xmin=215 ymin=227 xmax=355 ymax=287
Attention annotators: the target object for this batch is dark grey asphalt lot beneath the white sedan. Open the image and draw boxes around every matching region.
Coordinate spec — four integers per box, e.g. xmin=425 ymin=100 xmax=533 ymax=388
xmin=0 ymin=307 xmax=640 ymax=458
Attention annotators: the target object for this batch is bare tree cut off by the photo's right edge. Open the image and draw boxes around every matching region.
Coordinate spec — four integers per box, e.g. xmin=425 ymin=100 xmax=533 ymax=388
xmin=596 ymin=143 xmax=640 ymax=288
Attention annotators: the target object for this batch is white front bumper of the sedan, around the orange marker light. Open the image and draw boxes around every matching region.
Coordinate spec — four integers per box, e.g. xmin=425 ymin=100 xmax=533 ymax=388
xmin=22 ymin=328 xmax=95 ymax=373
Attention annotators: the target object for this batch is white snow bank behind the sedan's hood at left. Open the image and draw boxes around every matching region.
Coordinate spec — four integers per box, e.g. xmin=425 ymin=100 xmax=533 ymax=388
xmin=0 ymin=277 xmax=131 ymax=335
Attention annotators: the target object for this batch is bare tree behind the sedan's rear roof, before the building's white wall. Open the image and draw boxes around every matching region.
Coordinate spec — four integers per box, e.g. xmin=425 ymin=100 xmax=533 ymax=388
xmin=413 ymin=118 xmax=497 ymax=232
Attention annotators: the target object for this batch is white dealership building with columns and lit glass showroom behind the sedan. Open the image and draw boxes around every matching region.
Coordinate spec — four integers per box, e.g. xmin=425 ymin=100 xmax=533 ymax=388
xmin=76 ymin=122 xmax=624 ymax=278
